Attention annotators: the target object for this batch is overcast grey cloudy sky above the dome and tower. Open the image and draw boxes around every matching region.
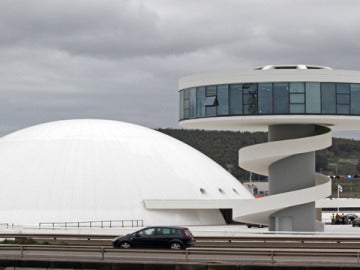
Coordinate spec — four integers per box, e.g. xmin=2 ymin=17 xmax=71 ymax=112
xmin=0 ymin=0 xmax=360 ymax=139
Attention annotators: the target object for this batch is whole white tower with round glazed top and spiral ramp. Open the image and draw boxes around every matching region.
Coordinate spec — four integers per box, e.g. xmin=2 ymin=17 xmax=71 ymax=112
xmin=179 ymin=65 xmax=360 ymax=231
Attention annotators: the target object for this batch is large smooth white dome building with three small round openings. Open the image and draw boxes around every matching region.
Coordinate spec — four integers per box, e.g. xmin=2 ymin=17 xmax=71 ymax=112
xmin=0 ymin=120 xmax=252 ymax=225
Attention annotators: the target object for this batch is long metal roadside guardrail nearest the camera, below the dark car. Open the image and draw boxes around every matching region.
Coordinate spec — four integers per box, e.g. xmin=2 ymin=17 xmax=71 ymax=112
xmin=0 ymin=246 xmax=360 ymax=267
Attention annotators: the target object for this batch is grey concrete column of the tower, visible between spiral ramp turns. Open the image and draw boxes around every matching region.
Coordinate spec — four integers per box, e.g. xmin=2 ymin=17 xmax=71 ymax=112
xmin=268 ymin=125 xmax=316 ymax=231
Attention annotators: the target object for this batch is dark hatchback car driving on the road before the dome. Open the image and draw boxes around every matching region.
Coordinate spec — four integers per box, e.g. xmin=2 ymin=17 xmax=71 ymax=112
xmin=112 ymin=226 xmax=195 ymax=249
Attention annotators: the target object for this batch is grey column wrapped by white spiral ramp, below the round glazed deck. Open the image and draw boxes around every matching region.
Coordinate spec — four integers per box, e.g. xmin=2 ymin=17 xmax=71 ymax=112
xmin=233 ymin=125 xmax=332 ymax=231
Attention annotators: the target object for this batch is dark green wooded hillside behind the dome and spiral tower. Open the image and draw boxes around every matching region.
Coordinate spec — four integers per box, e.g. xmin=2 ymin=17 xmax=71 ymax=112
xmin=158 ymin=129 xmax=360 ymax=181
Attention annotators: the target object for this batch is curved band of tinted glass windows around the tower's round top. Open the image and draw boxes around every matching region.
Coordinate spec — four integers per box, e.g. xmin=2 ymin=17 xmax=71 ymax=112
xmin=179 ymin=82 xmax=360 ymax=120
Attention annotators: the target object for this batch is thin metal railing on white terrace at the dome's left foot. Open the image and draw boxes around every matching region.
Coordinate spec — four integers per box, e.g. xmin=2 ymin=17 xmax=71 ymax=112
xmin=39 ymin=219 xmax=144 ymax=229
